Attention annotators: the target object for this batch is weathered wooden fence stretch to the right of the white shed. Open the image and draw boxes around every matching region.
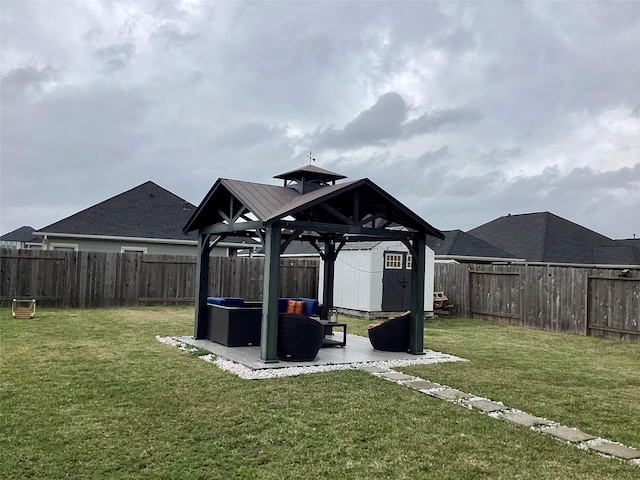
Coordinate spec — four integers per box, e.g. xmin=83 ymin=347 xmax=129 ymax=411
xmin=434 ymin=263 xmax=640 ymax=342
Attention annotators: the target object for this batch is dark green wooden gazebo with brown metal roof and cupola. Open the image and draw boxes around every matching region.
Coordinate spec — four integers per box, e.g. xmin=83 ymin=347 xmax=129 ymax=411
xmin=184 ymin=165 xmax=444 ymax=363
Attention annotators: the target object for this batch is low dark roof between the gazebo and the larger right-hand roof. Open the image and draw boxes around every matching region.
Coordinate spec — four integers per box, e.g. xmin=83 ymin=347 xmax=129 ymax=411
xmin=427 ymin=230 xmax=516 ymax=260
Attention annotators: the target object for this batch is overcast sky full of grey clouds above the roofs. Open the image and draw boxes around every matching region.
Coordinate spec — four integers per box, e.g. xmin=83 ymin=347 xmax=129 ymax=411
xmin=0 ymin=0 xmax=640 ymax=238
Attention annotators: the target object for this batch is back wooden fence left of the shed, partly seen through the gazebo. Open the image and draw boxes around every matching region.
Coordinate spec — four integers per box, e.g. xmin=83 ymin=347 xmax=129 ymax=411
xmin=0 ymin=249 xmax=319 ymax=308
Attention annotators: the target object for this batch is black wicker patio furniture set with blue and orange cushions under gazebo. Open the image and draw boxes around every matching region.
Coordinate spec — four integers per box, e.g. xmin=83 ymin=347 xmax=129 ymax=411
xmin=206 ymin=297 xmax=410 ymax=361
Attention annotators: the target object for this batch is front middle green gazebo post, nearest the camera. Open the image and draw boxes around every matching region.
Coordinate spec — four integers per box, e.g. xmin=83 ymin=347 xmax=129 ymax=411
xmin=260 ymin=223 xmax=282 ymax=363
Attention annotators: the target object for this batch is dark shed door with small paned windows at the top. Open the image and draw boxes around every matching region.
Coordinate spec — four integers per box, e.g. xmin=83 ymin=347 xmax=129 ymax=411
xmin=382 ymin=252 xmax=411 ymax=312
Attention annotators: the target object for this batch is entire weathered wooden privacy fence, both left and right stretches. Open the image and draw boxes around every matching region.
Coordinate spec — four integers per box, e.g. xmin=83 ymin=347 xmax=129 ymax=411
xmin=0 ymin=249 xmax=640 ymax=341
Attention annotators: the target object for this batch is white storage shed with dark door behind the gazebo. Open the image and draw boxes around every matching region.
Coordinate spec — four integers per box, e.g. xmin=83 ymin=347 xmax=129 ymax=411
xmin=318 ymin=242 xmax=435 ymax=317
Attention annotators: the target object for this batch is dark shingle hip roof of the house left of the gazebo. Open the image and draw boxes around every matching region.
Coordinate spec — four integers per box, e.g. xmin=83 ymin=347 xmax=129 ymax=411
xmin=38 ymin=181 xmax=197 ymax=240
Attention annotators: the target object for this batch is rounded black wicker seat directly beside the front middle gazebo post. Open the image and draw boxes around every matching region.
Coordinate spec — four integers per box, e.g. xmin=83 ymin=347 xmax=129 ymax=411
xmin=278 ymin=313 xmax=324 ymax=362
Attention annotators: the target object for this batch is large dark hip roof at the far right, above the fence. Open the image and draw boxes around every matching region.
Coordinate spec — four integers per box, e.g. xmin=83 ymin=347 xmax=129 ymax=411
xmin=467 ymin=212 xmax=640 ymax=265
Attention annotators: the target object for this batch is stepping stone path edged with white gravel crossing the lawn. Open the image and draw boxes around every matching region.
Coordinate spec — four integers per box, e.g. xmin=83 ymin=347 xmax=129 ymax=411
xmin=358 ymin=366 xmax=640 ymax=466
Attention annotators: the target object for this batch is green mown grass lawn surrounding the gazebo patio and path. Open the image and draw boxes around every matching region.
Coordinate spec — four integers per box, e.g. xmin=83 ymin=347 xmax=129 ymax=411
xmin=0 ymin=307 xmax=640 ymax=479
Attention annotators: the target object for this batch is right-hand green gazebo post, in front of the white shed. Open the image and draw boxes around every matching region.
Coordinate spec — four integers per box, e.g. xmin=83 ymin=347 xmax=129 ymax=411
xmin=409 ymin=234 xmax=427 ymax=355
